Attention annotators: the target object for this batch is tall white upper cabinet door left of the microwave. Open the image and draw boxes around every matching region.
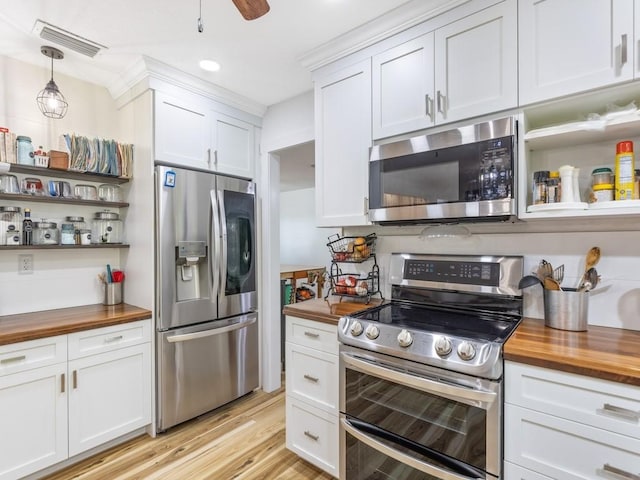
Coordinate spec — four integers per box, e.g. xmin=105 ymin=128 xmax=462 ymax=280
xmin=315 ymin=59 xmax=372 ymax=227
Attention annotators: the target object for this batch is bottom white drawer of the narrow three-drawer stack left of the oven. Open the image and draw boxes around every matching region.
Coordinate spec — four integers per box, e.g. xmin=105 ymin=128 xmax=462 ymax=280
xmin=286 ymin=396 xmax=339 ymax=478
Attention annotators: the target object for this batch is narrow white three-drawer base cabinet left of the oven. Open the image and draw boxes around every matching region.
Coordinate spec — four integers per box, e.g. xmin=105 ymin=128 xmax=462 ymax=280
xmin=285 ymin=316 xmax=339 ymax=478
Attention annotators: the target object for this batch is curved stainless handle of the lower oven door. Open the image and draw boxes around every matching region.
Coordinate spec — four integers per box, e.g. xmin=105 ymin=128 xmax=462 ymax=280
xmin=340 ymin=418 xmax=486 ymax=480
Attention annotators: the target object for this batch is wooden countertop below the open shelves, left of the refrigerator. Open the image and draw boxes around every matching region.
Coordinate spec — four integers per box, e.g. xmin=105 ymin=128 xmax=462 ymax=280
xmin=0 ymin=303 xmax=151 ymax=345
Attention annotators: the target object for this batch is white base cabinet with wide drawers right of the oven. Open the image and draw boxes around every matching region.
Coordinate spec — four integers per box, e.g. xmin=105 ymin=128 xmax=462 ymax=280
xmin=504 ymin=362 xmax=640 ymax=480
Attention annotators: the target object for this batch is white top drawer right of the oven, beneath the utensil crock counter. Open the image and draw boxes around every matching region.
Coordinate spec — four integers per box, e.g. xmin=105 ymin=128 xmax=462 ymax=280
xmin=504 ymin=362 xmax=640 ymax=440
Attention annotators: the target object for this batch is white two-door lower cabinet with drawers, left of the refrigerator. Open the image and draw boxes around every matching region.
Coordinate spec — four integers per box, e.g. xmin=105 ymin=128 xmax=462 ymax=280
xmin=0 ymin=320 xmax=151 ymax=480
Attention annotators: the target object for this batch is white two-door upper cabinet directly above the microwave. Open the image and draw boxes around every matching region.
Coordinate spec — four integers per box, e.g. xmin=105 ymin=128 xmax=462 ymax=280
xmin=372 ymin=0 xmax=518 ymax=139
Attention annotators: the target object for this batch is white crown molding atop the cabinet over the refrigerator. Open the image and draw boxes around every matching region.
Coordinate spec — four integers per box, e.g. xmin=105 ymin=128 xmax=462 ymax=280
xmin=108 ymin=56 xmax=267 ymax=117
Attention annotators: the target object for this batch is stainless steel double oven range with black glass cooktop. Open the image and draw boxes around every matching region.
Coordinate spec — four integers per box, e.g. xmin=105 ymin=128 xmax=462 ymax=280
xmin=338 ymin=254 xmax=523 ymax=480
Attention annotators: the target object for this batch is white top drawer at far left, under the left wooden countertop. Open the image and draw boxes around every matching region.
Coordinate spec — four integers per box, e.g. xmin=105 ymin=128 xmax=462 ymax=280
xmin=0 ymin=335 xmax=67 ymax=375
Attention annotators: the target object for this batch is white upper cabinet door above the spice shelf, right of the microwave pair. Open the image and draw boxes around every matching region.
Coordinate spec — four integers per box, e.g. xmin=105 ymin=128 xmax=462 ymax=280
xmin=518 ymin=0 xmax=637 ymax=105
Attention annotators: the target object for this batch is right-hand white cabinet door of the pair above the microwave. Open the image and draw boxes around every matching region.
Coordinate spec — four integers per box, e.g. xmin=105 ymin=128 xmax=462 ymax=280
xmin=435 ymin=0 xmax=518 ymax=123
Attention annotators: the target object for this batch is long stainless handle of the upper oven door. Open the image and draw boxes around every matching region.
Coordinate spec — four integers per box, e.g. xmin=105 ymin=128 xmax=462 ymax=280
xmin=342 ymin=352 xmax=497 ymax=404
